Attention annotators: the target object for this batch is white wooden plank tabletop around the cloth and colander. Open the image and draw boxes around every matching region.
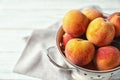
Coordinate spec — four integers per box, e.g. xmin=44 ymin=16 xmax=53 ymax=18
xmin=0 ymin=0 xmax=120 ymax=80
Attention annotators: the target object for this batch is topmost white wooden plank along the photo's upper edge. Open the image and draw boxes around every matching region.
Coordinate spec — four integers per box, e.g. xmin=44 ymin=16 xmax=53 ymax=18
xmin=0 ymin=0 xmax=120 ymax=9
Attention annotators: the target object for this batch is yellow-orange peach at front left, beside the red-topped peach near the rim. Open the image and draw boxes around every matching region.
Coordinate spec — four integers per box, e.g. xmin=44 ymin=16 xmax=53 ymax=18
xmin=65 ymin=38 xmax=95 ymax=66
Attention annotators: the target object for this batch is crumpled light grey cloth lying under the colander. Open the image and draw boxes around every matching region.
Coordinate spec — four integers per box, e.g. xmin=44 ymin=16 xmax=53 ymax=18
xmin=14 ymin=21 xmax=73 ymax=80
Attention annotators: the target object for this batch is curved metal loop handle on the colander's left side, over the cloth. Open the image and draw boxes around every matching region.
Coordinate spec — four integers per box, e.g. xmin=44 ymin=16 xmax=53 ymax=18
xmin=47 ymin=47 xmax=76 ymax=70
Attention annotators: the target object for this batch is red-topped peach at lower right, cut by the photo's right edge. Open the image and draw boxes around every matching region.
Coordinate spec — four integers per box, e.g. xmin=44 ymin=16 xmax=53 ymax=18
xmin=96 ymin=46 xmax=120 ymax=70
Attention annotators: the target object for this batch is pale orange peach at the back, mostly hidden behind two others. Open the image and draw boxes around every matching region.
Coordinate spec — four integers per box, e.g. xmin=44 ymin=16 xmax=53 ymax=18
xmin=82 ymin=8 xmax=103 ymax=21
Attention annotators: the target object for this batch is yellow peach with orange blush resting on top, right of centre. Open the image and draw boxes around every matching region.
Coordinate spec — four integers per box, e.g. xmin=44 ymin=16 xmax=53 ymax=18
xmin=86 ymin=18 xmax=115 ymax=46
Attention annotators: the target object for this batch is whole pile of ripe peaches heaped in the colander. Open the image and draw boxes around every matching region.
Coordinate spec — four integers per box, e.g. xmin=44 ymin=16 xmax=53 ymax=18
xmin=62 ymin=8 xmax=120 ymax=70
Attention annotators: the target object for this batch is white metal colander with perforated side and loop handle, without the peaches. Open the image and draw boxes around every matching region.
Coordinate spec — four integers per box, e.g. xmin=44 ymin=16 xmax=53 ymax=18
xmin=47 ymin=26 xmax=120 ymax=80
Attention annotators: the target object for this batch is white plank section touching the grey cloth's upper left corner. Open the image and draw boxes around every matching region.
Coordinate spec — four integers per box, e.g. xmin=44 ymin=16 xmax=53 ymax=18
xmin=0 ymin=29 xmax=32 ymax=52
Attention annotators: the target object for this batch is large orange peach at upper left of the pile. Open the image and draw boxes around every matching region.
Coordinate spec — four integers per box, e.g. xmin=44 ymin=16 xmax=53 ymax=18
xmin=62 ymin=10 xmax=89 ymax=37
